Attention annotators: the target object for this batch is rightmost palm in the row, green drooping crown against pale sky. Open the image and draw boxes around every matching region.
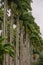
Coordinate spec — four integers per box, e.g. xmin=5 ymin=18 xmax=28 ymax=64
xmin=20 ymin=8 xmax=41 ymax=65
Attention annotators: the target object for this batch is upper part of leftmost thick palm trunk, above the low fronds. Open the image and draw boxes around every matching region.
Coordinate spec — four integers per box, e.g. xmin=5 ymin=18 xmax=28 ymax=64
xmin=2 ymin=0 xmax=7 ymax=43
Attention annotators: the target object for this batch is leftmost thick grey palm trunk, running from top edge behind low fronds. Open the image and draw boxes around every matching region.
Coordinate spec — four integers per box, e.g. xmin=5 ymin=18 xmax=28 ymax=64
xmin=2 ymin=0 xmax=7 ymax=65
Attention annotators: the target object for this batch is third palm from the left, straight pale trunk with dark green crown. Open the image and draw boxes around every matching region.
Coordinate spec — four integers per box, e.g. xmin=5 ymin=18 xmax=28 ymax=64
xmin=7 ymin=0 xmax=31 ymax=65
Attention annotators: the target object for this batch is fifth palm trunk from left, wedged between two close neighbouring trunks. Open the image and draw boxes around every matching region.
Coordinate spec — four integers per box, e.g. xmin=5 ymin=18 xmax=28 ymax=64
xmin=22 ymin=31 xmax=28 ymax=65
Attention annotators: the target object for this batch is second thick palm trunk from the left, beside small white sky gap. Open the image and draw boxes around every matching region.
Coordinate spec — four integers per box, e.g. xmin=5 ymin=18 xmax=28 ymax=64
xmin=10 ymin=11 xmax=14 ymax=65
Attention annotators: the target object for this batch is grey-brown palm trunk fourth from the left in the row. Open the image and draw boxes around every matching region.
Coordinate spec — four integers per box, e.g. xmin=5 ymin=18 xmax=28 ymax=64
xmin=19 ymin=21 xmax=24 ymax=65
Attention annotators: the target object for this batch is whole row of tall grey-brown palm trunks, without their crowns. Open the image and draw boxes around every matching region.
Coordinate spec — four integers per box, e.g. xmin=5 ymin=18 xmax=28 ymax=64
xmin=2 ymin=0 xmax=31 ymax=65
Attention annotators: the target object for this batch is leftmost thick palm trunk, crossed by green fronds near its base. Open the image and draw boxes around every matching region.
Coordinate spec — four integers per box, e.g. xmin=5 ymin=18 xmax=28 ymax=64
xmin=2 ymin=0 xmax=8 ymax=65
